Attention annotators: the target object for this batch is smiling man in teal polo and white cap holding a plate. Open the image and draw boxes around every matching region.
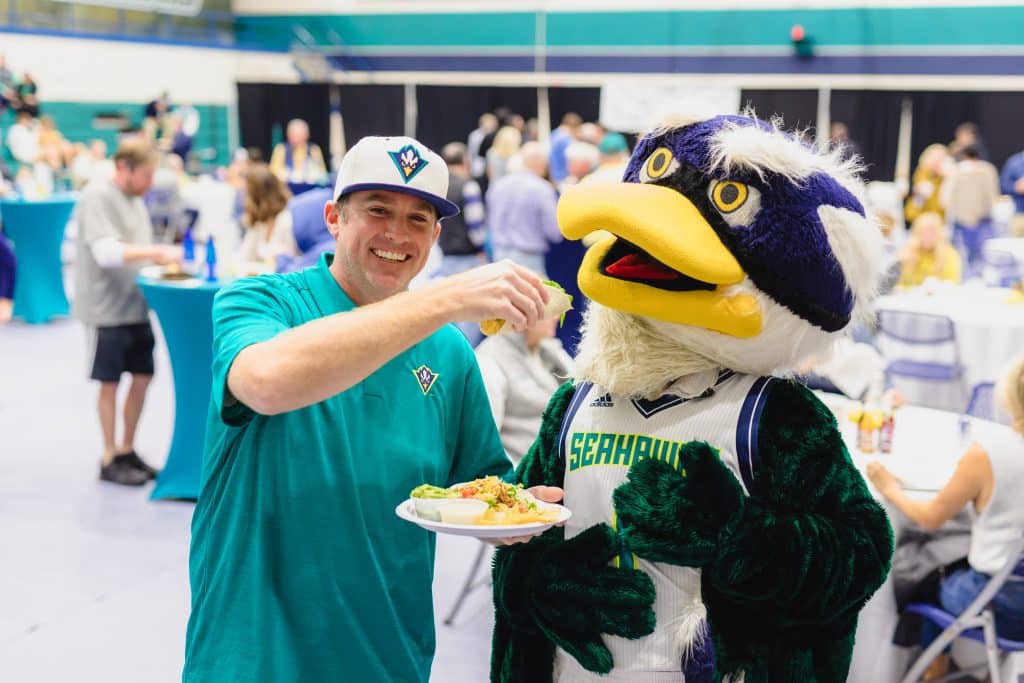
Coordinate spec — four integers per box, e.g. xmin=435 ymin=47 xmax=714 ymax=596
xmin=182 ymin=137 xmax=561 ymax=683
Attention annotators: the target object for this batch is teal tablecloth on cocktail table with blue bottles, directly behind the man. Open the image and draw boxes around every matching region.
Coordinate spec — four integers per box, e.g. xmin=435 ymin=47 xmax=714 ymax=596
xmin=138 ymin=276 xmax=225 ymax=500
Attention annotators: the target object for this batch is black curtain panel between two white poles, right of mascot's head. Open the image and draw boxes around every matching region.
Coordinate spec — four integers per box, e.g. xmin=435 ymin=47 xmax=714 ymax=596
xmin=831 ymin=90 xmax=904 ymax=180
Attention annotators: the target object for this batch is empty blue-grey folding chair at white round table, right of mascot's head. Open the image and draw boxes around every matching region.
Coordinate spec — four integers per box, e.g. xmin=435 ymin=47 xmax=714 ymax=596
xmin=879 ymin=310 xmax=967 ymax=404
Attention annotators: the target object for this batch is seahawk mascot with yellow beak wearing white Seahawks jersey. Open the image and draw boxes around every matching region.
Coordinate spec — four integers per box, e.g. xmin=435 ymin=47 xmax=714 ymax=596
xmin=492 ymin=116 xmax=893 ymax=683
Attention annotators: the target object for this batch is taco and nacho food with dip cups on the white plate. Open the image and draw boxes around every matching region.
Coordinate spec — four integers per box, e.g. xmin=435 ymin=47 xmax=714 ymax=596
xmin=410 ymin=476 xmax=559 ymax=526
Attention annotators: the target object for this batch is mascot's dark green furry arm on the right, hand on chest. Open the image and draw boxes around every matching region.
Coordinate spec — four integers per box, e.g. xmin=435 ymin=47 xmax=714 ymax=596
xmin=614 ymin=381 xmax=893 ymax=681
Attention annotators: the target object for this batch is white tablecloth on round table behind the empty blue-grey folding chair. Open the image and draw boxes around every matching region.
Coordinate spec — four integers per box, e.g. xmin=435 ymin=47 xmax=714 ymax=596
xmin=876 ymin=286 xmax=1024 ymax=412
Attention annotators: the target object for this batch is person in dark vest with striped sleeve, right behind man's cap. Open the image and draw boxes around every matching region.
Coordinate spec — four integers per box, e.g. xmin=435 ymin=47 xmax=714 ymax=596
xmin=434 ymin=142 xmax=486 ymax=346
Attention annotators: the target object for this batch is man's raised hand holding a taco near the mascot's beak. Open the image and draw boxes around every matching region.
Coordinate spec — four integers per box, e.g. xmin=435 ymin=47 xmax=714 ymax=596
xmin=424 ymin=260 xmax=548 ymax=332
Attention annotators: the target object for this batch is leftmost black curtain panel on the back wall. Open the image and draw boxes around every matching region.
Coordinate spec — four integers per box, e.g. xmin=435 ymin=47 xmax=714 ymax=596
xmin=238 ymin=83 xmax=330 ymax=161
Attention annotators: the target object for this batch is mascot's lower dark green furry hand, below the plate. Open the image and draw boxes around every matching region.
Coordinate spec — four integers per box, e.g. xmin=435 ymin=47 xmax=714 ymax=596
xmin=495 ymin=524 xmax=654 ymax=674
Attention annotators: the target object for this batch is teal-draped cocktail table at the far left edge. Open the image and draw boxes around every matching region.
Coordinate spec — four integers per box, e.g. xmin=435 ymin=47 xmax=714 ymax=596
xmin=0 ymin=196 xmax=75 ymax=325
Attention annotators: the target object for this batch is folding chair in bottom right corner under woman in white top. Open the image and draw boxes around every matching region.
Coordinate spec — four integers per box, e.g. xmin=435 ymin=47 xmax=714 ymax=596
xmin=901 ymin=536 xmax=1024 ymax=683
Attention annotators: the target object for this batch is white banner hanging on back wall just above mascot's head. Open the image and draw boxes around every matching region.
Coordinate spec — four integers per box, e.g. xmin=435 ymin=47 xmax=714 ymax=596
xmin=600 ymin=80 xmax=739 ymax=133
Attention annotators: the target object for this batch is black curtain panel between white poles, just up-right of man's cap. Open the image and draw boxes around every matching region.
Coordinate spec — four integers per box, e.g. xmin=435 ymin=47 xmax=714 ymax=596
xmin=416 ymin=85 xmax=537 ymax=150
